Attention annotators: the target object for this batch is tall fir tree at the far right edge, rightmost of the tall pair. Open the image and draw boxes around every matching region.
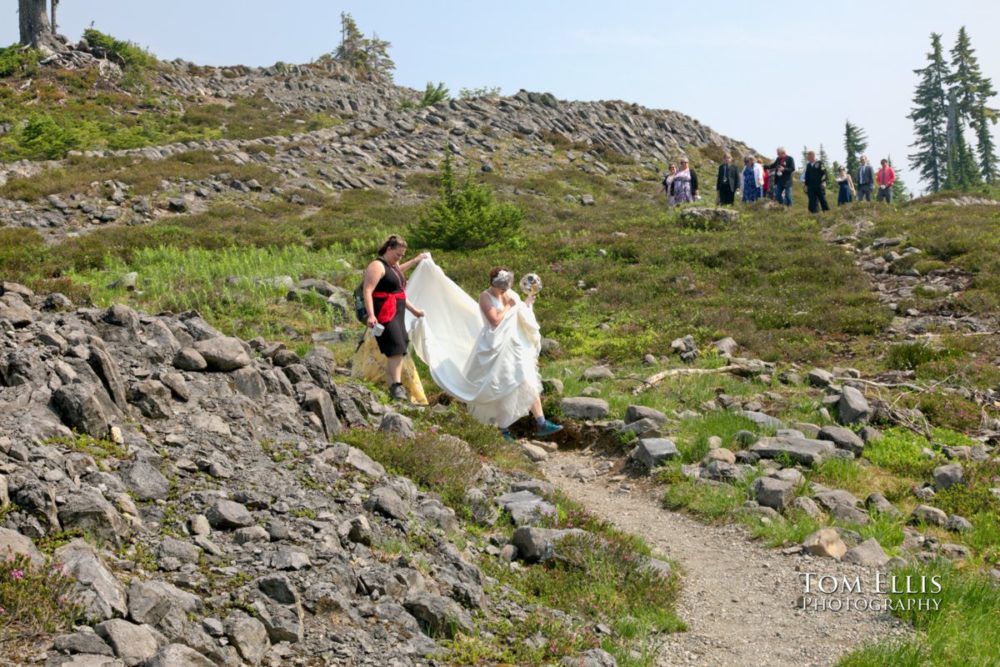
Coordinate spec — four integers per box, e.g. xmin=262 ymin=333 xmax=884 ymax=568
xmin=948 ymin=26 xmax=997 ymax=182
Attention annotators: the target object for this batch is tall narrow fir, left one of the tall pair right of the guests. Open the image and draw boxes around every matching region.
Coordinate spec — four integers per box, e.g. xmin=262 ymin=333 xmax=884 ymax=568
xmin=908 ymin=33 xmax=949 ymax=192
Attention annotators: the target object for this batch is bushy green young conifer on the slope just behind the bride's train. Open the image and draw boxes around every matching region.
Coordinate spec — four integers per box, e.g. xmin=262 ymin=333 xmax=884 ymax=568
xmin=411 ymin=151 xmax=524 ymax=250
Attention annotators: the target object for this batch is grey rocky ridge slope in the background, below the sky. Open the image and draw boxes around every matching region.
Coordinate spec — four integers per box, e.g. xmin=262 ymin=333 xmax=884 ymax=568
xmin=0 ymin=45 xmax=749 ymax=233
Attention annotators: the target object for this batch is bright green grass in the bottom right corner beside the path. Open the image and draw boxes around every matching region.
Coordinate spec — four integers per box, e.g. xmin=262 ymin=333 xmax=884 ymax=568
xmin=838 ymin=562 xmax=1000 ymax=667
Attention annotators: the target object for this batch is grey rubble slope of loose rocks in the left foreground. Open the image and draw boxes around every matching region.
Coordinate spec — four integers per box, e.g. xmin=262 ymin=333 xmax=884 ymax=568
xmin=0 ymin=283 xmax=670 ymax=667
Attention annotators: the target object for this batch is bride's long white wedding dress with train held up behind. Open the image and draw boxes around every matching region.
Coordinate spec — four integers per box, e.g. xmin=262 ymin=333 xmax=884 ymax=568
xmin=406 ymin=258 xmax=542 ymax=428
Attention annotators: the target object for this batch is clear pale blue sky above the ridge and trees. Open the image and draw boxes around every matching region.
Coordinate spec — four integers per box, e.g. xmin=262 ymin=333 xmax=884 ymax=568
xmin=0 ymin=0 xmax=1000 ymax=193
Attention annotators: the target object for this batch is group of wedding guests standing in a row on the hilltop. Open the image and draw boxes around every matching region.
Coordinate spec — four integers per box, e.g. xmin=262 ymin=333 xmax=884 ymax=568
xmin=663 ymin=147 xmax=896 ymax=213
